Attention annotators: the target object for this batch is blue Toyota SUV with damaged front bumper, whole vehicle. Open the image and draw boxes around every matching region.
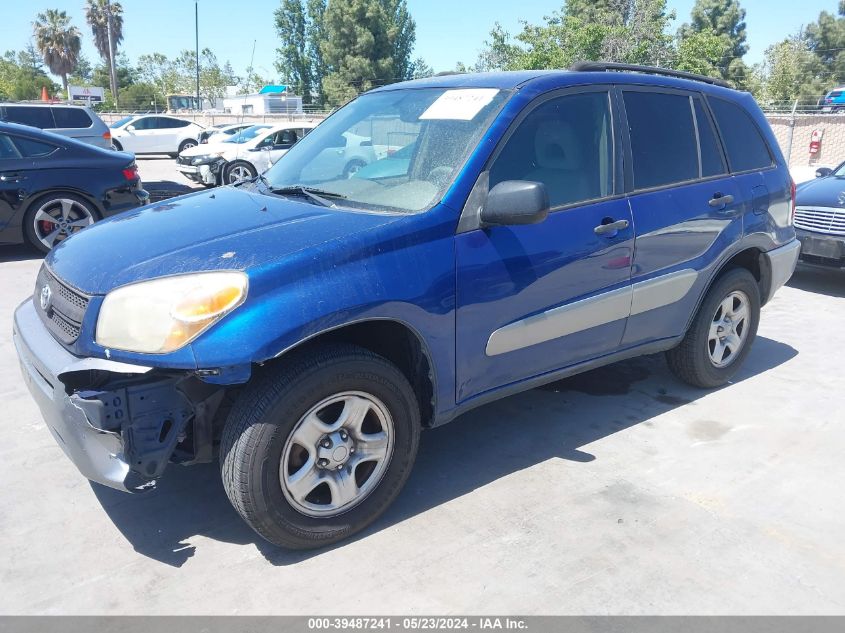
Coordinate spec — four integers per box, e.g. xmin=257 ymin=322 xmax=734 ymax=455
xmin=14 ymin=63 xmax=799 ymax=548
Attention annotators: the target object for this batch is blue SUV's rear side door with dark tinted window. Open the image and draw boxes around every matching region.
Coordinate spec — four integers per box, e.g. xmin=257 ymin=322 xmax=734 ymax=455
xmin=621 ymin=87 xmax=743 ymax=347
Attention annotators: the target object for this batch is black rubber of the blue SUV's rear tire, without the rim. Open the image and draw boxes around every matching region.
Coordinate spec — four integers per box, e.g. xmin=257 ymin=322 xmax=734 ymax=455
xmin=666 ymin=268 xmax=760 ymax=389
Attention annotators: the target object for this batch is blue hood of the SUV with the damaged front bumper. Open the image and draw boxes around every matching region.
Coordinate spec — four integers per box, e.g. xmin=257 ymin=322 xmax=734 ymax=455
xmin=45 ymin=185 xmax=402 ymax=294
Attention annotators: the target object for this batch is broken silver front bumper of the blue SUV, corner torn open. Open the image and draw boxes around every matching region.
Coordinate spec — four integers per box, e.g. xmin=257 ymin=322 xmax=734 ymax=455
xmin=13 ymin=299 xmax=224 ymax=492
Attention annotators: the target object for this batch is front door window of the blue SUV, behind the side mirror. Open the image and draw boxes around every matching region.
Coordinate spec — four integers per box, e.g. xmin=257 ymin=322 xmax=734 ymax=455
xmin=490 ymin=92 xmax=613 ymax=208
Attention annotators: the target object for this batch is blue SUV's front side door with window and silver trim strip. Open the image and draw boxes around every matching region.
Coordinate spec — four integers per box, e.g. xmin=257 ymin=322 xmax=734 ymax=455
xmin=456 ymin=87 xmax=634 ymax=402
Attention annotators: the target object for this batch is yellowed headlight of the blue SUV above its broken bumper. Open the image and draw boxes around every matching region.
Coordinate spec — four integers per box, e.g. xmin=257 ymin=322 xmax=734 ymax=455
xmin=96 ymin=271 xmax=248 ymax=354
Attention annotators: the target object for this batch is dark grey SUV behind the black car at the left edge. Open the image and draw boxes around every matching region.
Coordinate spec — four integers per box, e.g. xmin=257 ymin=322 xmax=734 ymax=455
xmin=0 ymin=103 xmax=112 ymax=149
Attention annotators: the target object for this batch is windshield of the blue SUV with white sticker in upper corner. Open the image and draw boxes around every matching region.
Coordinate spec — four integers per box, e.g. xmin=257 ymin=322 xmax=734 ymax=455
xmin=265 ymin=88 xmax=509 ymax=212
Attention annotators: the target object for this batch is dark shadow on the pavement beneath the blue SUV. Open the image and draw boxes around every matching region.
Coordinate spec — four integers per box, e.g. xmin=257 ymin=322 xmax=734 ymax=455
xmin=92 ymin=337 xmax=798 ymax=567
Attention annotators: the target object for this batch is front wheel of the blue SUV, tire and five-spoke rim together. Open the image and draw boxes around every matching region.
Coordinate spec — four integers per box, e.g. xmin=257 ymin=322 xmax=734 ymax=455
xmin=220 ymin=344 xmax=420 ymax=549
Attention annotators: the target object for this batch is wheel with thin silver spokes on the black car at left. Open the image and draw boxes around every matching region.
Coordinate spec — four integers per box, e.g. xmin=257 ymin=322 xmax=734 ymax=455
xmin=24 ymin=193 xmax=97 ymax=253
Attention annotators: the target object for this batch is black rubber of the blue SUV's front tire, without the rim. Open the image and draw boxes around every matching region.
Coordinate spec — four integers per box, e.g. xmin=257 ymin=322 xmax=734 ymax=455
xmin=220 ymin=344 xmax=420 ymax=549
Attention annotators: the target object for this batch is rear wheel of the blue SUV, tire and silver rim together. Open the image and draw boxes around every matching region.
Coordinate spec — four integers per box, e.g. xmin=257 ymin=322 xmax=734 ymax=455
xmin=666 ymin=268 xmax=760 ymax=388
